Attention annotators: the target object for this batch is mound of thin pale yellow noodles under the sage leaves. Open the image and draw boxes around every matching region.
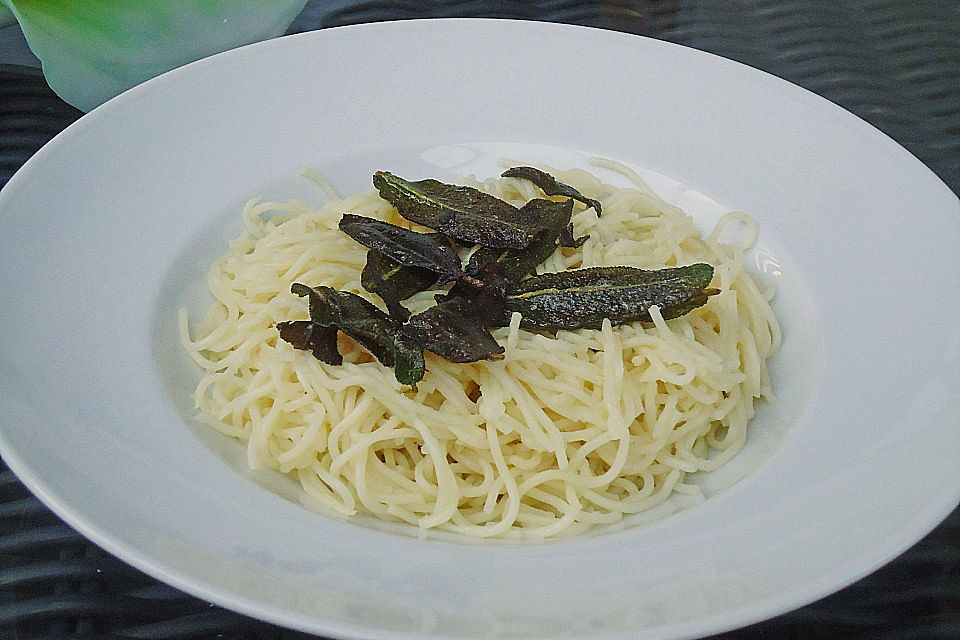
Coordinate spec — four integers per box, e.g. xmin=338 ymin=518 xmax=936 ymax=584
xmin=181 ymin=161 xmax=780 ymax=539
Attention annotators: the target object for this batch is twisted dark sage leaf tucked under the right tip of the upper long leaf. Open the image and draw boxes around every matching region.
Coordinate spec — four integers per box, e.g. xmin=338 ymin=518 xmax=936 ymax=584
xmin=467 ymin=198 xmax=573 ymax=282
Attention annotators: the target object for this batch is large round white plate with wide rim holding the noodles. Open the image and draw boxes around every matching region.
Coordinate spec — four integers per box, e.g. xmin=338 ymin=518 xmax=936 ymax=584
xmin=0 ymin=20 xmax=960 ymax=638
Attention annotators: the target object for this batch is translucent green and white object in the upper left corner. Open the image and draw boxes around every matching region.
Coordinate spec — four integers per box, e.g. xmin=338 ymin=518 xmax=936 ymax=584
xmin=0 ymin=0 xmax=306 ymax=111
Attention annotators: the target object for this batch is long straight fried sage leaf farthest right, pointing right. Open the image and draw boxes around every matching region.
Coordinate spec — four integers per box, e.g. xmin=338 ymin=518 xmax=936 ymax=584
xmin=505 ymin=263 xmax=713 ymax=329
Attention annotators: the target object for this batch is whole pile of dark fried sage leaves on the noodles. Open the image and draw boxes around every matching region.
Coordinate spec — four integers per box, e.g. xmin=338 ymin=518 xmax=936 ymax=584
xmin=277 ymin=167 xmax=719 ymax=388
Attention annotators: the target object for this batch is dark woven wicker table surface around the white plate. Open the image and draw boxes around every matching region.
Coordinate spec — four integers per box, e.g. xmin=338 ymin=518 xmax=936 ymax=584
xmin=0 ymin=0 xmax=960 ymax=640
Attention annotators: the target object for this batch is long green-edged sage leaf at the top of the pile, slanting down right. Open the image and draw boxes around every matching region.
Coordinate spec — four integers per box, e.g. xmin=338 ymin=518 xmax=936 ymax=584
xmin=373 ymin=171 xmax=538 ymax=249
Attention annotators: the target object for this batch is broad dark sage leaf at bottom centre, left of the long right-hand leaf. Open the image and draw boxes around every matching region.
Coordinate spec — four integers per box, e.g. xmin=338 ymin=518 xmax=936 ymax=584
xmin=401 ymin=298 xmax=503 ymax=362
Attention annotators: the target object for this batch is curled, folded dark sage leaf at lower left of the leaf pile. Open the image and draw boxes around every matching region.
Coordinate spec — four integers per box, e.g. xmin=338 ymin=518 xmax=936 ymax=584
xmin=281 ymin=282 xmax=424 ymax=385
